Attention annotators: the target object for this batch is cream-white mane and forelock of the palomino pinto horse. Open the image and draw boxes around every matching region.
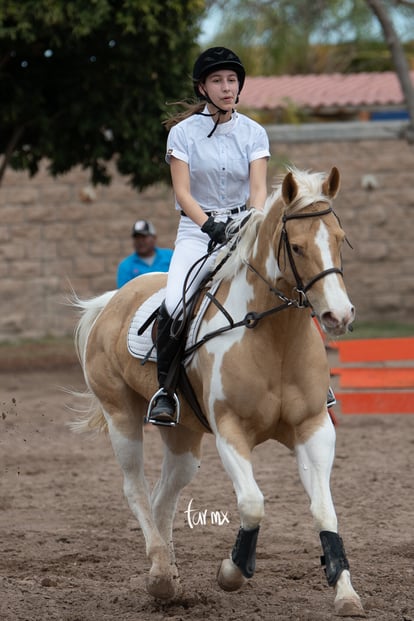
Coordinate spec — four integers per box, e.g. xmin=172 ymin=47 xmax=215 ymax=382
xmin=213 ymin=166 xmax=331 ymax=282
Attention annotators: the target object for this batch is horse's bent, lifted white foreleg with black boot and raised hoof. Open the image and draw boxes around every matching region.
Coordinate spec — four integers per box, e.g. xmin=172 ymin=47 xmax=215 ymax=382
xmin=216 ymin=436 xmax=264 ymax=591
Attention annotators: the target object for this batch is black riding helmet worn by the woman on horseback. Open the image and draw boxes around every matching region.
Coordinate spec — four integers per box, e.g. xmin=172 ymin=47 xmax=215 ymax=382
xmin=193 ymin=47 xmax=246 ymax=99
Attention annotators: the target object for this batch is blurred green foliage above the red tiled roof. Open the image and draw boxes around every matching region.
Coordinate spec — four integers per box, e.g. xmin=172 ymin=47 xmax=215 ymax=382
xmin=202 ymin=0 xmax=414 ymax=75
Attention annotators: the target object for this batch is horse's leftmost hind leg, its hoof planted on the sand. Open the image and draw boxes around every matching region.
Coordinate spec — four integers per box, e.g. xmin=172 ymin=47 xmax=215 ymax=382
xmin=107 ymin=415 xmax=178 ymax=599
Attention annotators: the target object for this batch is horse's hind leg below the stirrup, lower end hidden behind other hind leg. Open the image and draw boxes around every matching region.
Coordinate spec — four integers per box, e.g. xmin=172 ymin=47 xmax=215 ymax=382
xmin=151 ymin=426 xmax=203 ymax=563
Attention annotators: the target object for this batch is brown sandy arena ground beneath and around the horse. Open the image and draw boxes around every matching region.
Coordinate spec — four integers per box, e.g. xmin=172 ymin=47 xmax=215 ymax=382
xmin=0 ymin=354 xmax=414 ymax=621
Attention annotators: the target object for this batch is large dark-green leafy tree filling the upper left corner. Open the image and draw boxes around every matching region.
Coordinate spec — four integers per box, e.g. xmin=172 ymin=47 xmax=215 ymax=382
xmin=0 ymin=0 xmax=204 ymax=188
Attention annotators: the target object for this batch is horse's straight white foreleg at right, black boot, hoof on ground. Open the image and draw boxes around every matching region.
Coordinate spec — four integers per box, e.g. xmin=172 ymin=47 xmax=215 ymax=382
xmin=295 ymin=414 xmax=365 ymax=617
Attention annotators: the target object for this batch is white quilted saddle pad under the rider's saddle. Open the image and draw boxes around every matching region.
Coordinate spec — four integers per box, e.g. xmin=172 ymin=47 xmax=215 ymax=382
xmin=127 ymin=283 xmax=220 ymax=365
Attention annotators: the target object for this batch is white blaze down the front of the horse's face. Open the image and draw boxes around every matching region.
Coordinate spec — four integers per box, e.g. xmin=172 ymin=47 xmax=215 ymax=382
xmin=315 ymin=221 xmax=352 ymax=318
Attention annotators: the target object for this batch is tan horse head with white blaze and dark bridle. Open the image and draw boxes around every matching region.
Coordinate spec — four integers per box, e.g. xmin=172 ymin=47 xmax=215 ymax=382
xmin=271 ymin=167 xmax=355 ymax=336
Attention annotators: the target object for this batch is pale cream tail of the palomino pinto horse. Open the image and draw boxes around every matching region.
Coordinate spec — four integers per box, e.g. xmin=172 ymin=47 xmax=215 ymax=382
xmin=69 ymin=291 xmax=116 ymax=433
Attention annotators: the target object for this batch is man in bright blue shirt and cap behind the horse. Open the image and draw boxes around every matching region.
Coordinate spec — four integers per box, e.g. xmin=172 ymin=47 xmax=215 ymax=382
xmin=117 ymin=220 xmax=172 ymax=288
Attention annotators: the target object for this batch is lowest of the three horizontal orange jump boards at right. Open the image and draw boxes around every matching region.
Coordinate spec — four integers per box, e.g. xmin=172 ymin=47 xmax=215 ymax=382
xmin=336 ymin=391 xmax=414 ymax=414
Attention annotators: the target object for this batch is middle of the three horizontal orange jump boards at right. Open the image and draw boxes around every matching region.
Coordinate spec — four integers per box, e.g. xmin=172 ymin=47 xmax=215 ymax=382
xmin=331 ymin=367 xmax=414 ymax=389
